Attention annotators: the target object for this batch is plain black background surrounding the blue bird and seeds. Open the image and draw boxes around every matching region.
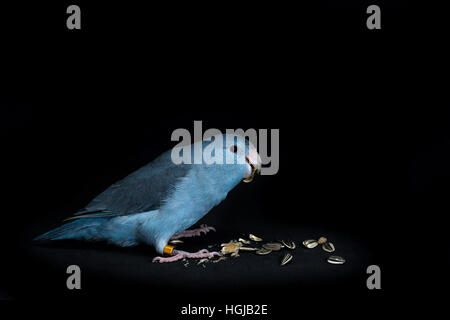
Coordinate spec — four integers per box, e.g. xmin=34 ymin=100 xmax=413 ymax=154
xmin=0 ymin=1 xmax=444 ymax=318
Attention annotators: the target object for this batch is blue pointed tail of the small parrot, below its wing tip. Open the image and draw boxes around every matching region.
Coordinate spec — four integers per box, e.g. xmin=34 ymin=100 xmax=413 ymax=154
xmin=33 ymin=218 xmax=104 ymax=241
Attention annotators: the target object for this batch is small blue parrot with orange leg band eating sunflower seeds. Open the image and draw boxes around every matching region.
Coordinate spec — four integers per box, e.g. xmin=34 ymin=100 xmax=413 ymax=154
xmin=34 ymin=133 xmax=261 ymax=263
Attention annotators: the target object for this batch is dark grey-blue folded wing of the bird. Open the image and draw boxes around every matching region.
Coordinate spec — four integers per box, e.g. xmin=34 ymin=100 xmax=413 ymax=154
xmin=68 ymin=151 xmax=192 ymax=220
